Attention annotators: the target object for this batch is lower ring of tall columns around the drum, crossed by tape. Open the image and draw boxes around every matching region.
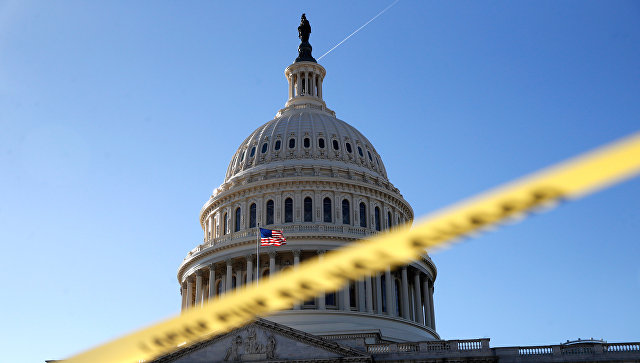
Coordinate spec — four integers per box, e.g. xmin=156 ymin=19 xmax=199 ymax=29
xmin=181 ymin=250 xmax=435 ymax=330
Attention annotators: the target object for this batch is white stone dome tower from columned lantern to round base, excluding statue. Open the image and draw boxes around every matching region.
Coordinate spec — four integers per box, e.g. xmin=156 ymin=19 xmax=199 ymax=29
xmin=178 ymin=62 xmax=439 ymax=342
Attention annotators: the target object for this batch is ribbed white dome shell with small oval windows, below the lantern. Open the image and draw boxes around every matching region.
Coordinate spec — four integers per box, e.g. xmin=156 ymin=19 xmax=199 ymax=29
xmin=225 ymin=108 xmax=387 ymax=183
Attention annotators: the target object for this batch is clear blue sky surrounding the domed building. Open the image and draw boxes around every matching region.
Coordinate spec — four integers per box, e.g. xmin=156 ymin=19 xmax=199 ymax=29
xmin=0 ymin=0 xmax=640 ymax=362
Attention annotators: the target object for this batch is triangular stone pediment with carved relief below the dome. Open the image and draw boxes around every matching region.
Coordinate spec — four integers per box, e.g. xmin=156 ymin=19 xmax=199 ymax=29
xmin=154 ymin=319 xmax=371 ymax=363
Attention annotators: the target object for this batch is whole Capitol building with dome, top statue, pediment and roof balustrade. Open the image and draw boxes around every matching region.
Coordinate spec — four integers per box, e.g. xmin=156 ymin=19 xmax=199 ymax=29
xmin=156 ymin=15 xmax=640 ymax=362
